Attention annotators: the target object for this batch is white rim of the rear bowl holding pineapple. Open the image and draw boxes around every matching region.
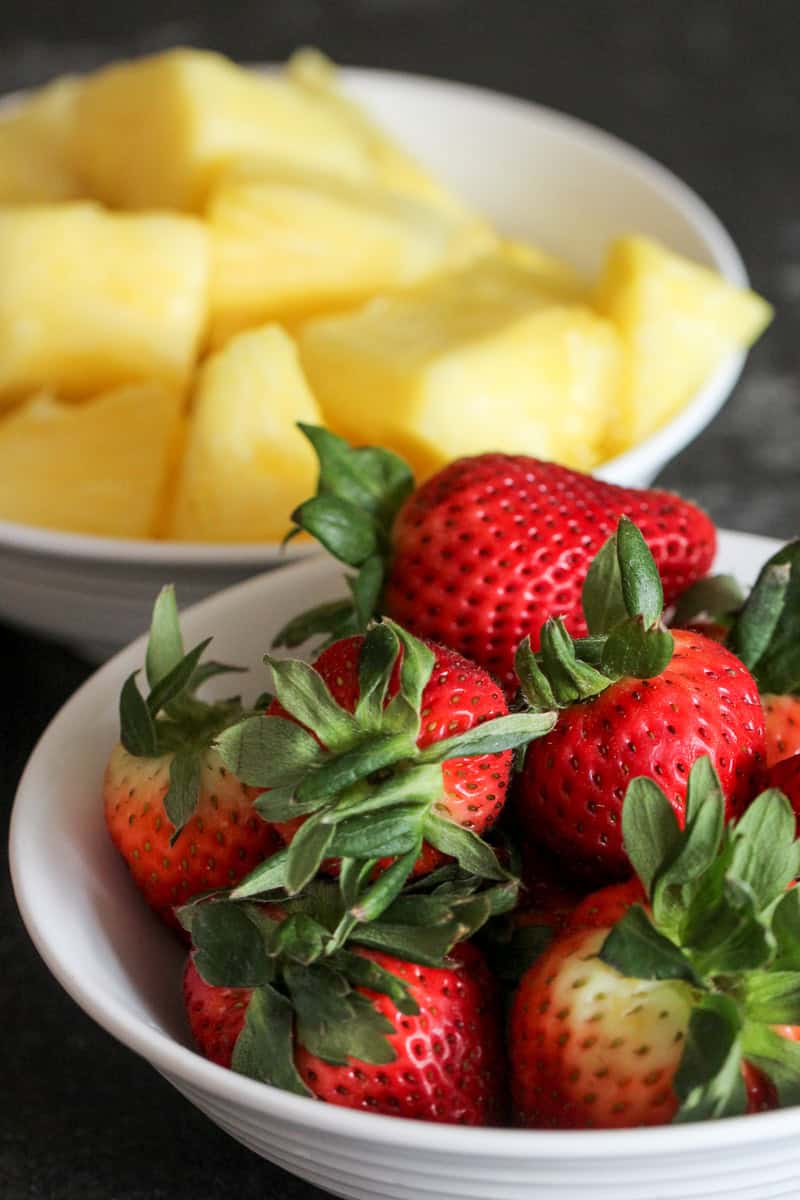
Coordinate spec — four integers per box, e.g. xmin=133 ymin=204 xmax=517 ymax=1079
xmin=0 ymin=62 xmax=750 ymax=570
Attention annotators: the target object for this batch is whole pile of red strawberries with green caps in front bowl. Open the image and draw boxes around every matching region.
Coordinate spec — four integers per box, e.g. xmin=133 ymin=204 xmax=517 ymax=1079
xmin=104 ymin=427 xmax=800 ymax=1128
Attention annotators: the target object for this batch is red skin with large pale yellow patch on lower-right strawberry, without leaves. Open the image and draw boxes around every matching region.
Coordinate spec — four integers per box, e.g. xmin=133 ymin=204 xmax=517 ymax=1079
xmin=509 ymin=912 xmax=800 ymax=1129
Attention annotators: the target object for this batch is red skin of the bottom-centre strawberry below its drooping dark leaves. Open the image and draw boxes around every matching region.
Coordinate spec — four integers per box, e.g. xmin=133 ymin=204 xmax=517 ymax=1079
xmin=184 ymin=944 xmax=506 ymax=1126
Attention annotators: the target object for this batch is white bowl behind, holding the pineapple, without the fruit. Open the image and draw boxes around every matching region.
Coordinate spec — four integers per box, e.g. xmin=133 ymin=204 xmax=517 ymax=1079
xmin=0 ymin=70 xmax=747 ymax=660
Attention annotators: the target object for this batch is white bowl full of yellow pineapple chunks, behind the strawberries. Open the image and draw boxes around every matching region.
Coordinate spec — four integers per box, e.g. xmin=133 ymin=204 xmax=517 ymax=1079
xmin=0 ymin=49 xmax=770 ymax=658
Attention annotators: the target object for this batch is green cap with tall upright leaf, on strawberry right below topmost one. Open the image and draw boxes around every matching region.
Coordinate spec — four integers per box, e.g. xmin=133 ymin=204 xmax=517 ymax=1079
xmin=515 ymin=517 xmax=674 ymax=712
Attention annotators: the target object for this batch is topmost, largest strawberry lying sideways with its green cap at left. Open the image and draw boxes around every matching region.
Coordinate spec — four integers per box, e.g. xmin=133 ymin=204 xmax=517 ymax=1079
xmin=279 ymin=426 xmax=716 ymax=694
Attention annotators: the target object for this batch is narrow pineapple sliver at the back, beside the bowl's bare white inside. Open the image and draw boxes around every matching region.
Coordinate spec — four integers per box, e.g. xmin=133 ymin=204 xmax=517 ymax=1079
xmin=287 ymin=48 xmax=468 ymax=216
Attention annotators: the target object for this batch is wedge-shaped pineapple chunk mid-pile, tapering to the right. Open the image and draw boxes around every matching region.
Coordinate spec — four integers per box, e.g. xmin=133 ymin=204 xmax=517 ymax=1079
xmin=209 ymin=168 xmax=497 ymax=346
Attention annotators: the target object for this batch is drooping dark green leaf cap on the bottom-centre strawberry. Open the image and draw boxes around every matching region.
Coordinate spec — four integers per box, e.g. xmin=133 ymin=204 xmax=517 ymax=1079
xmin=178 ymin=865 xmax=506 ymax=1096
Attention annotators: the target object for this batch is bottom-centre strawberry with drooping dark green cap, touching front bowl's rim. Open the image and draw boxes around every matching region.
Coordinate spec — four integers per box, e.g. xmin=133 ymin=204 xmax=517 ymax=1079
xmin=178 ymin=883 xmax=505 ymax=1124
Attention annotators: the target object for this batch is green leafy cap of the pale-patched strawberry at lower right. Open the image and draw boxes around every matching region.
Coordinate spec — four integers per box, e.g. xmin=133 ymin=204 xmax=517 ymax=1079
xmin=600 ymin=758 xmax=800 ymax=1122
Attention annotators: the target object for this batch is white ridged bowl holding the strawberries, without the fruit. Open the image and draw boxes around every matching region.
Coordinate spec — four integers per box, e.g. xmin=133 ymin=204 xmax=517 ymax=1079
xmin=11 ymin=534 xmax=800 ymax=1200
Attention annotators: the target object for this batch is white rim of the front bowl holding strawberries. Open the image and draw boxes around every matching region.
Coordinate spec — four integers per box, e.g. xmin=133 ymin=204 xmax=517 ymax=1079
xmin=8 ymin=530 xmax=800 ymax=1160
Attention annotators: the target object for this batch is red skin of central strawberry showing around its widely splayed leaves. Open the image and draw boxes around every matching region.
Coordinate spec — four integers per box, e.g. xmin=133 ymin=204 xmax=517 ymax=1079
xmin=273 ymin=635 xmax=511 ymax=859
